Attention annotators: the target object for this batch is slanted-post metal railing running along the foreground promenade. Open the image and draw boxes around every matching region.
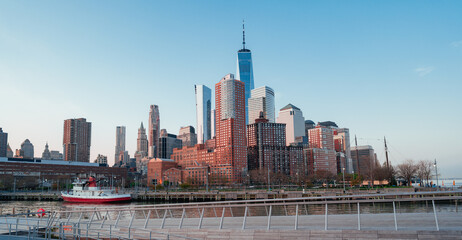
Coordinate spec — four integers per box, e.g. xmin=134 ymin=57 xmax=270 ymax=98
xmin=0 ymin=191 xmax=462 ymax=239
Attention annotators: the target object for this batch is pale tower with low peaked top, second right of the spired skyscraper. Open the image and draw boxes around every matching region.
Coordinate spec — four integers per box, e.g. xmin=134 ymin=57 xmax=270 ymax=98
xmin=277 ymin=104 xmax=305 ymax=146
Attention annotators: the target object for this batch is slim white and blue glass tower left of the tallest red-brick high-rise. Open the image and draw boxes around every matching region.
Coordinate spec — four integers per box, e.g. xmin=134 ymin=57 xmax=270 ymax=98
xmin=194 ymin=85 xmax=212 ymax=143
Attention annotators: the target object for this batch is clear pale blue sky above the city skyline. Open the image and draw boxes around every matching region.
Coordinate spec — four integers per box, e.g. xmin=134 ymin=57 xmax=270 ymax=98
xmin=0 ymin=1 xmax=462 ymax=177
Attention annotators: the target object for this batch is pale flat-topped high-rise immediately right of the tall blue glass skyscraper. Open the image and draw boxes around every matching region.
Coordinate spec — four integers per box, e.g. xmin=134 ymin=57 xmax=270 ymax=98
xmin=248 ymin=86 xmax=276 ymax=124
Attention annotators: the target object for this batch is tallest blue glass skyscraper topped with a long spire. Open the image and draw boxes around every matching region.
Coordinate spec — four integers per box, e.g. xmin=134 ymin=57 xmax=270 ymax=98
xmin=236 ymin=21 xmax=254 ymax=124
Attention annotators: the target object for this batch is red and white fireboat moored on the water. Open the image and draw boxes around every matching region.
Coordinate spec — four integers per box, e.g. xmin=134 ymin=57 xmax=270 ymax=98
xmin=61 ymin=177 xmax=131 ymax=203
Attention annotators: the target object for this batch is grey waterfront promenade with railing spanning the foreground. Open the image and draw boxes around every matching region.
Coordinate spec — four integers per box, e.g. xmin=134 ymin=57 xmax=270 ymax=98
xmin=0 ymin=191 xmax=462 ymax=239
